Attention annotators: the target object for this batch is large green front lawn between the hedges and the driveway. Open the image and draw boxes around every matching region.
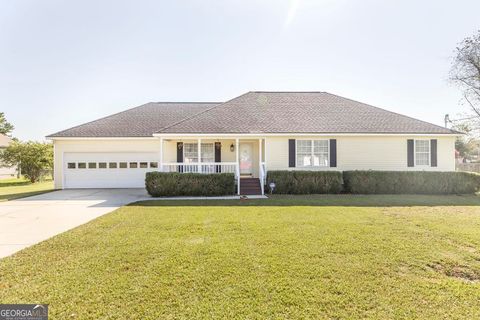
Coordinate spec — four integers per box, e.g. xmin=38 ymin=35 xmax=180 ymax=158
xmin=0 ymin=196 xmax=480 ymax=319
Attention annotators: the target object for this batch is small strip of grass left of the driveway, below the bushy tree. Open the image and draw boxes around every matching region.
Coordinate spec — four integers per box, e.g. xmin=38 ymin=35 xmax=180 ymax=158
xmin=0 ymin=179 xmax=53 ymax=201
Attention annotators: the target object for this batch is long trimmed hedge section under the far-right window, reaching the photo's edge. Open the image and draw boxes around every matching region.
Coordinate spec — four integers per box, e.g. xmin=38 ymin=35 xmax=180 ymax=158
xmin=343 ymin=171 xmax=480 ymax=194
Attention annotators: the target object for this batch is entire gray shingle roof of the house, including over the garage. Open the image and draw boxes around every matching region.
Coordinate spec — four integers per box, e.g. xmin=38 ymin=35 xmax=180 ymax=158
xmin=49 ymin=91 xmax=458 ymax=138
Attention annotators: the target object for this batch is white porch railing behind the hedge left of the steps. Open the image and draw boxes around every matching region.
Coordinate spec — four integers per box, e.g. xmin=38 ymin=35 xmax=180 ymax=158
xmin=162 ymin=162 xmax=237 ymax=176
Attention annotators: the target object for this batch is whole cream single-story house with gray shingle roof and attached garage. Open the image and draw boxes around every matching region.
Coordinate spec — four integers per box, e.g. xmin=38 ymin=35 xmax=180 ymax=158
xmin=47 ymin=92 xmax=460 ymax=193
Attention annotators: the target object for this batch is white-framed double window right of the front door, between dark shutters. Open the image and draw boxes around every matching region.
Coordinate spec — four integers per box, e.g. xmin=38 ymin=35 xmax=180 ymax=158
xmin=297 ymin=140 xmax=328 ymax=167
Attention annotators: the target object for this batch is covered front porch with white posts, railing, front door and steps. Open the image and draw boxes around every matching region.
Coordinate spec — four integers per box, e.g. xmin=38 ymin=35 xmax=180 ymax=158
xmin=158 ymin=137 xmax=266 ymax=195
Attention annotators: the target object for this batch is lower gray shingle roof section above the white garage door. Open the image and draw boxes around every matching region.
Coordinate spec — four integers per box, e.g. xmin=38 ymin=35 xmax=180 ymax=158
xmin=48 ymin=102 xmax=218 ymax=138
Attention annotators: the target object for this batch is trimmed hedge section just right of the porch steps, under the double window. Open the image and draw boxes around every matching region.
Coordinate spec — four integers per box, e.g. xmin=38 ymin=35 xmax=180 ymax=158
xmin=267 ymin=171 xmax=342 ymax=194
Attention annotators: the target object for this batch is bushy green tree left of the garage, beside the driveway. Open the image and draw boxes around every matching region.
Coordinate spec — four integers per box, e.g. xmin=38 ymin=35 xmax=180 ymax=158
xmin=0 ymin=141 xmax=53 ymax=183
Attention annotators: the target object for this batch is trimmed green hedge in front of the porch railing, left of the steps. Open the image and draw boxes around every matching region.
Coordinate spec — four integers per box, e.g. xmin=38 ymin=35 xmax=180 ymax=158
xmin=145 ymin=172 xmax=235 ymax=197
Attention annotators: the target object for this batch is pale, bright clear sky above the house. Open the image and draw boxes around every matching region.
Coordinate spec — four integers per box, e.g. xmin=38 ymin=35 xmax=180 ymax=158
xmin=0 ymin=0 xmax=480 ymax=140
